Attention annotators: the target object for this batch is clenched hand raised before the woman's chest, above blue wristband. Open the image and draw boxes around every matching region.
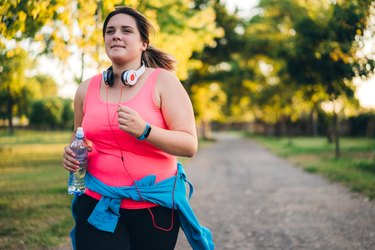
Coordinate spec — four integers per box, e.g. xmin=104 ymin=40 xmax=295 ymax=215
xmin=117 ymin=105 xmax=146 ymax=137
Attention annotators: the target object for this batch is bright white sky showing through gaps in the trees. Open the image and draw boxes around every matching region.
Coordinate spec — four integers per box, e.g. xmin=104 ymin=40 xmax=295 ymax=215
xmin=45 ymin=0 xmax=375 ymax=108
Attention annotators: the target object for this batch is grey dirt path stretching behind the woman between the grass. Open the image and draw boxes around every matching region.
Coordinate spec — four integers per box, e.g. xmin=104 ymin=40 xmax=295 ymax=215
xmin=176 ymin=134 xmax=375 ymax=250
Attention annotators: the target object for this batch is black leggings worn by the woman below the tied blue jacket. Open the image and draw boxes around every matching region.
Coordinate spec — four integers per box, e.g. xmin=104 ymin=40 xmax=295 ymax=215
xmin=75 ymin=195 xmax=180 ymax=250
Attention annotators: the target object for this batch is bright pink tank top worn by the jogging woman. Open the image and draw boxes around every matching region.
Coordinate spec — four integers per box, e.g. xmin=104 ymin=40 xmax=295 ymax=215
xmin=82 ymin=69 xmax=177 ymax=209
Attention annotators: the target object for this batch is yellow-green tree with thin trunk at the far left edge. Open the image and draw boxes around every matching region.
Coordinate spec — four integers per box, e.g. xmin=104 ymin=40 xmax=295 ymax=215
xmin=0 ymin=0 xmax=69 ymax=132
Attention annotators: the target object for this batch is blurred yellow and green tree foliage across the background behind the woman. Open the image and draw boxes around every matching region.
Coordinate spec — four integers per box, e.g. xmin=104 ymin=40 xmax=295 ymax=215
xmin=0 ymin=0 xmax=374 ymax=136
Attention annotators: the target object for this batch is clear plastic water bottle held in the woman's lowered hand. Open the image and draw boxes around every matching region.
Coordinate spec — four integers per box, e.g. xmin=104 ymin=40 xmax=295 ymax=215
xmin=68 ymin=127 xmax=88 ymax=196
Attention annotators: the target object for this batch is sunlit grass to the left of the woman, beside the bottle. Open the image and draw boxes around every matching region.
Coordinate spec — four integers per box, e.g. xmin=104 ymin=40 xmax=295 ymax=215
xmin=0 ymin=131 xmax=73 ymax=250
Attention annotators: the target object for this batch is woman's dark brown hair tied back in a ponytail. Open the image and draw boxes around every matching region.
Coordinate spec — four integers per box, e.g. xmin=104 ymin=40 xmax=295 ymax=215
xmin=103 ymin=6 xmax=175 ymax=70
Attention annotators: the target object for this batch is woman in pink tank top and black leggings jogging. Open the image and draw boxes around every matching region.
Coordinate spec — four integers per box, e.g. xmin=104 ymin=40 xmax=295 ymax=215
xmin=63 ymin=7 xmax=213 ymax=250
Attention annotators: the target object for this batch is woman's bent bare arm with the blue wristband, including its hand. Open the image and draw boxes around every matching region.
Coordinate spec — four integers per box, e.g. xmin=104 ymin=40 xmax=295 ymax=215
xmin=118 ymin=70 xmax=198 ymax=157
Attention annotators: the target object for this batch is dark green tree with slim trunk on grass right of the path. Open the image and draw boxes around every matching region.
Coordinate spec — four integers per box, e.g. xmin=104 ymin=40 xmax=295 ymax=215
xmin=288 ymin=1 xmax=375 ymax=158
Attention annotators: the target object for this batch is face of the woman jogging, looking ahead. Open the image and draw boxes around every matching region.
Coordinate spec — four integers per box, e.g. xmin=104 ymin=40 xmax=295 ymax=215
xmin=104 ymin=14 xmax=147 ymax=64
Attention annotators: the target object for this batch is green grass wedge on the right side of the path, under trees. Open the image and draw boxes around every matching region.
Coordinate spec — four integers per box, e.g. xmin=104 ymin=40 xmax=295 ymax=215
xmin=253 ymin=136 xmax=375 ymax=199
